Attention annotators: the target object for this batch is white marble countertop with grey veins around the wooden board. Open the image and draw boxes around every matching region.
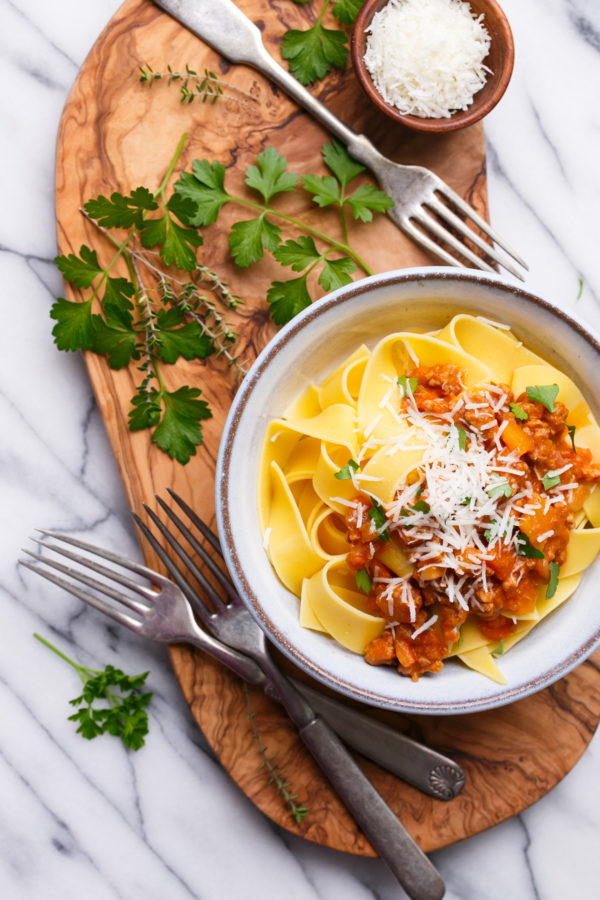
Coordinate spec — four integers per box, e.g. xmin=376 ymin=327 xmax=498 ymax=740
xmin=0 ymin=0 xmax=600 ymax=900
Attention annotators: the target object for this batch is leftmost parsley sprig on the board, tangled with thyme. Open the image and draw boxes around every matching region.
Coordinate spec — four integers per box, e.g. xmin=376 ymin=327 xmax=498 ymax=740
xmin=50 ymin=135 xmax=245 ymax=464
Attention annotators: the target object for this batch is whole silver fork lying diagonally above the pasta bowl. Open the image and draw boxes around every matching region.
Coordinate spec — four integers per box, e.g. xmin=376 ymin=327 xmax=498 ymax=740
xmin=155 ymin=0 xmax=528 ymax=281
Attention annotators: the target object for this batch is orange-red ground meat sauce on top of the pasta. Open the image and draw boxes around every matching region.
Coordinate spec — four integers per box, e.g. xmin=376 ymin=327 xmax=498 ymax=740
xmin=346 ymin=364 xmax=600 ymax=680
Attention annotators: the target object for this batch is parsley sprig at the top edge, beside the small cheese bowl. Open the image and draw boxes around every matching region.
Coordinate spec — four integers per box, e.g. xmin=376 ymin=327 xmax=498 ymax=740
xmin=281 ymin=0 xmax=364 ymax=84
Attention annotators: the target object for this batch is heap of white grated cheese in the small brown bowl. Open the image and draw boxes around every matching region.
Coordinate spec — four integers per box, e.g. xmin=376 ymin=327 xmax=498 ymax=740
xmin=364 ymin=0 xmax=490 ymax=119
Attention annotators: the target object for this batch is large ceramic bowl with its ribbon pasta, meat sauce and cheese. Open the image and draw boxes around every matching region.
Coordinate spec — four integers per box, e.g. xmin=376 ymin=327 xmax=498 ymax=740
xmin=217 ymin=270 xmax=600 ymax=712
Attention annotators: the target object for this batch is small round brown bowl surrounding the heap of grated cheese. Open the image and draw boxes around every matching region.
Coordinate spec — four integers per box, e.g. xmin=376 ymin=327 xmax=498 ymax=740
xmin=352 ymin=0 xmax=515 ymax=133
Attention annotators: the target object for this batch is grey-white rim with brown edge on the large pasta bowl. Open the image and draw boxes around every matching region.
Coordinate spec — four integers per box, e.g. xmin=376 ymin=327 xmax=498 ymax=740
xmin=215 ymin=267 xmax=600 ymax=715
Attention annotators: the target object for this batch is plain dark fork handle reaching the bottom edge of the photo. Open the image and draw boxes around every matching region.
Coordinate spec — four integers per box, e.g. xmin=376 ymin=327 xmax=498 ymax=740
xmin=300 ymin=718 xmax=445 ymax=900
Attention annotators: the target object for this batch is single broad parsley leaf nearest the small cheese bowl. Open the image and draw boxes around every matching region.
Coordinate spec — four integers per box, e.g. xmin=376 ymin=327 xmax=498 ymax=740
xmin=281 ymin=20 xmax=348 ymax=84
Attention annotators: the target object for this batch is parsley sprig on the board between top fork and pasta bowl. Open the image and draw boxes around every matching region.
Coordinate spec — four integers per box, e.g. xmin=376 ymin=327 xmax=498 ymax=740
xmin=175 ymin=139 xmax=393 ymax=325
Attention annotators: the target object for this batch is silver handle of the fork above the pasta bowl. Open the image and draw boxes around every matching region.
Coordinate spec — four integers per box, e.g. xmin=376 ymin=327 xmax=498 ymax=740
xmin=155 ymin=0 xmax=386 ymax=171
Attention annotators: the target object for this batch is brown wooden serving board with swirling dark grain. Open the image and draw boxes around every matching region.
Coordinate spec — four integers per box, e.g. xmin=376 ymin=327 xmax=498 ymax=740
xmin=56 ymin=0 xmax=600 ymax=856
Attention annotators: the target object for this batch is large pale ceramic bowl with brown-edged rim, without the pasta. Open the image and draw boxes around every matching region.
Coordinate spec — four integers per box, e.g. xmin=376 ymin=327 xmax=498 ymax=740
xmin=216 ymin=268 xmax=600 ymax=715
